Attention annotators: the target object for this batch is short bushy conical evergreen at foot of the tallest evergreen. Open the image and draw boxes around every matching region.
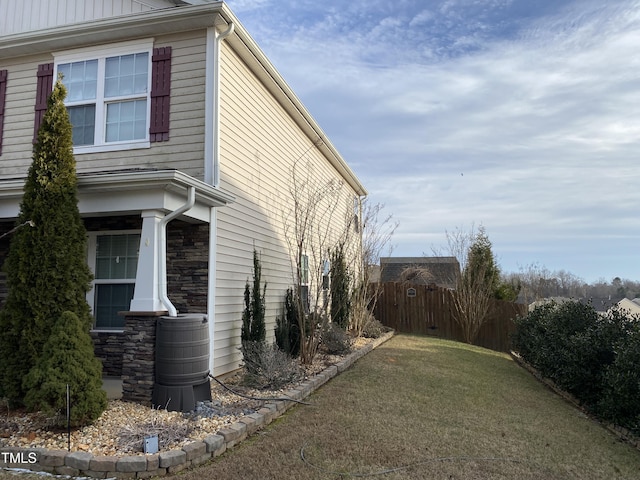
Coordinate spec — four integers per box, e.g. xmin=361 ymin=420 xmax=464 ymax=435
xmin=23 ymin=312 xmax=107 ymax=426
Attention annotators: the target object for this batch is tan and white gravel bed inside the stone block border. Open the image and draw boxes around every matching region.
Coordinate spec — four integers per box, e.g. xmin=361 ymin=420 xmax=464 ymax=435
xmin=0 ymin=346 xmax=357 ymax=455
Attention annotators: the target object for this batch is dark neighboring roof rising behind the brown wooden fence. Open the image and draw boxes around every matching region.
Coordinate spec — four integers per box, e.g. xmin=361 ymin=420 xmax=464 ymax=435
xmin=380 ymin=257 xmax=460 ymax=289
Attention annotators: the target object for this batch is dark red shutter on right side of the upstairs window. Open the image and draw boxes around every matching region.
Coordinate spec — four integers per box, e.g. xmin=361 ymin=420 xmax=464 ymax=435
xmin=149 ymin=47 xmax=171 ymax=142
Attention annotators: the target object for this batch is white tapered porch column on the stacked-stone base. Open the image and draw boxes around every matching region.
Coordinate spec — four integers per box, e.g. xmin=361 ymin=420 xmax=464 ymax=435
xmin=129 ymin=210 xmax=167 ymax=312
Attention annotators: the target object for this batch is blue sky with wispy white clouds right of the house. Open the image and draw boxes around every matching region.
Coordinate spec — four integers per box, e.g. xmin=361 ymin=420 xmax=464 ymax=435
xmin=227 ymin=0 xmax=640 ymax=282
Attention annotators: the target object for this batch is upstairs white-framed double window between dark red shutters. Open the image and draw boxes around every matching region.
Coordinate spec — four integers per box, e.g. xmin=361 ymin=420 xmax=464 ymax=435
xmin=55 ymin=42 xmax=152 ymax=151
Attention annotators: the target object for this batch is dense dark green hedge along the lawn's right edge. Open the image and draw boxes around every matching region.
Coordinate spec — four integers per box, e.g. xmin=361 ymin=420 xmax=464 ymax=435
xmin=513 ymin=302 xmax=640 ymax=433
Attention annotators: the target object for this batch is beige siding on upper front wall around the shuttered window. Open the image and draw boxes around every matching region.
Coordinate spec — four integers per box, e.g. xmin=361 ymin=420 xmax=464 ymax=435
xmin=0 ymin=30 xmax=206 ymax=180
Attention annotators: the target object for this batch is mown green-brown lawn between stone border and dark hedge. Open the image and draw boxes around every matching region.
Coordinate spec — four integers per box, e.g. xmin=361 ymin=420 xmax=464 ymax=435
xmin=174 ymin=335 xmax=640 ymax=480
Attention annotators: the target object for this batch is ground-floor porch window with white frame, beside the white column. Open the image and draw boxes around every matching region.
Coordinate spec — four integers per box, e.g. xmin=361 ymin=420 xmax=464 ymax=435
xmin=88 ymin=232 xmax=140 ymax=330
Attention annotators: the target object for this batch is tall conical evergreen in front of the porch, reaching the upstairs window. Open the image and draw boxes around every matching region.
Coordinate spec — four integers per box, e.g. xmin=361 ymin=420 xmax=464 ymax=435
xmin=0 ymin=80 xmax=97 ymax=404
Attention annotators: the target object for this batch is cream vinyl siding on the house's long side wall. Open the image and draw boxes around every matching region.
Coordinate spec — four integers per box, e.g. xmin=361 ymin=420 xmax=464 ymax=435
xmin=214 ymin=43 xmax=354 ymax=375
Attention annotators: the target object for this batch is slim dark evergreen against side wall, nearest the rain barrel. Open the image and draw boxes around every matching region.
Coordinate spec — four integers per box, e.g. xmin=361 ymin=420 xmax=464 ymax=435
xmin=240 ymin=250 xmax=267 ymax=345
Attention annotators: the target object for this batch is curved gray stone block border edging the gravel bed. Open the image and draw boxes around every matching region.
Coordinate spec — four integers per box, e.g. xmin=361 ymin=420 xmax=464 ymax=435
xmin=0 ymin=332 xmax=394 ymax=478
